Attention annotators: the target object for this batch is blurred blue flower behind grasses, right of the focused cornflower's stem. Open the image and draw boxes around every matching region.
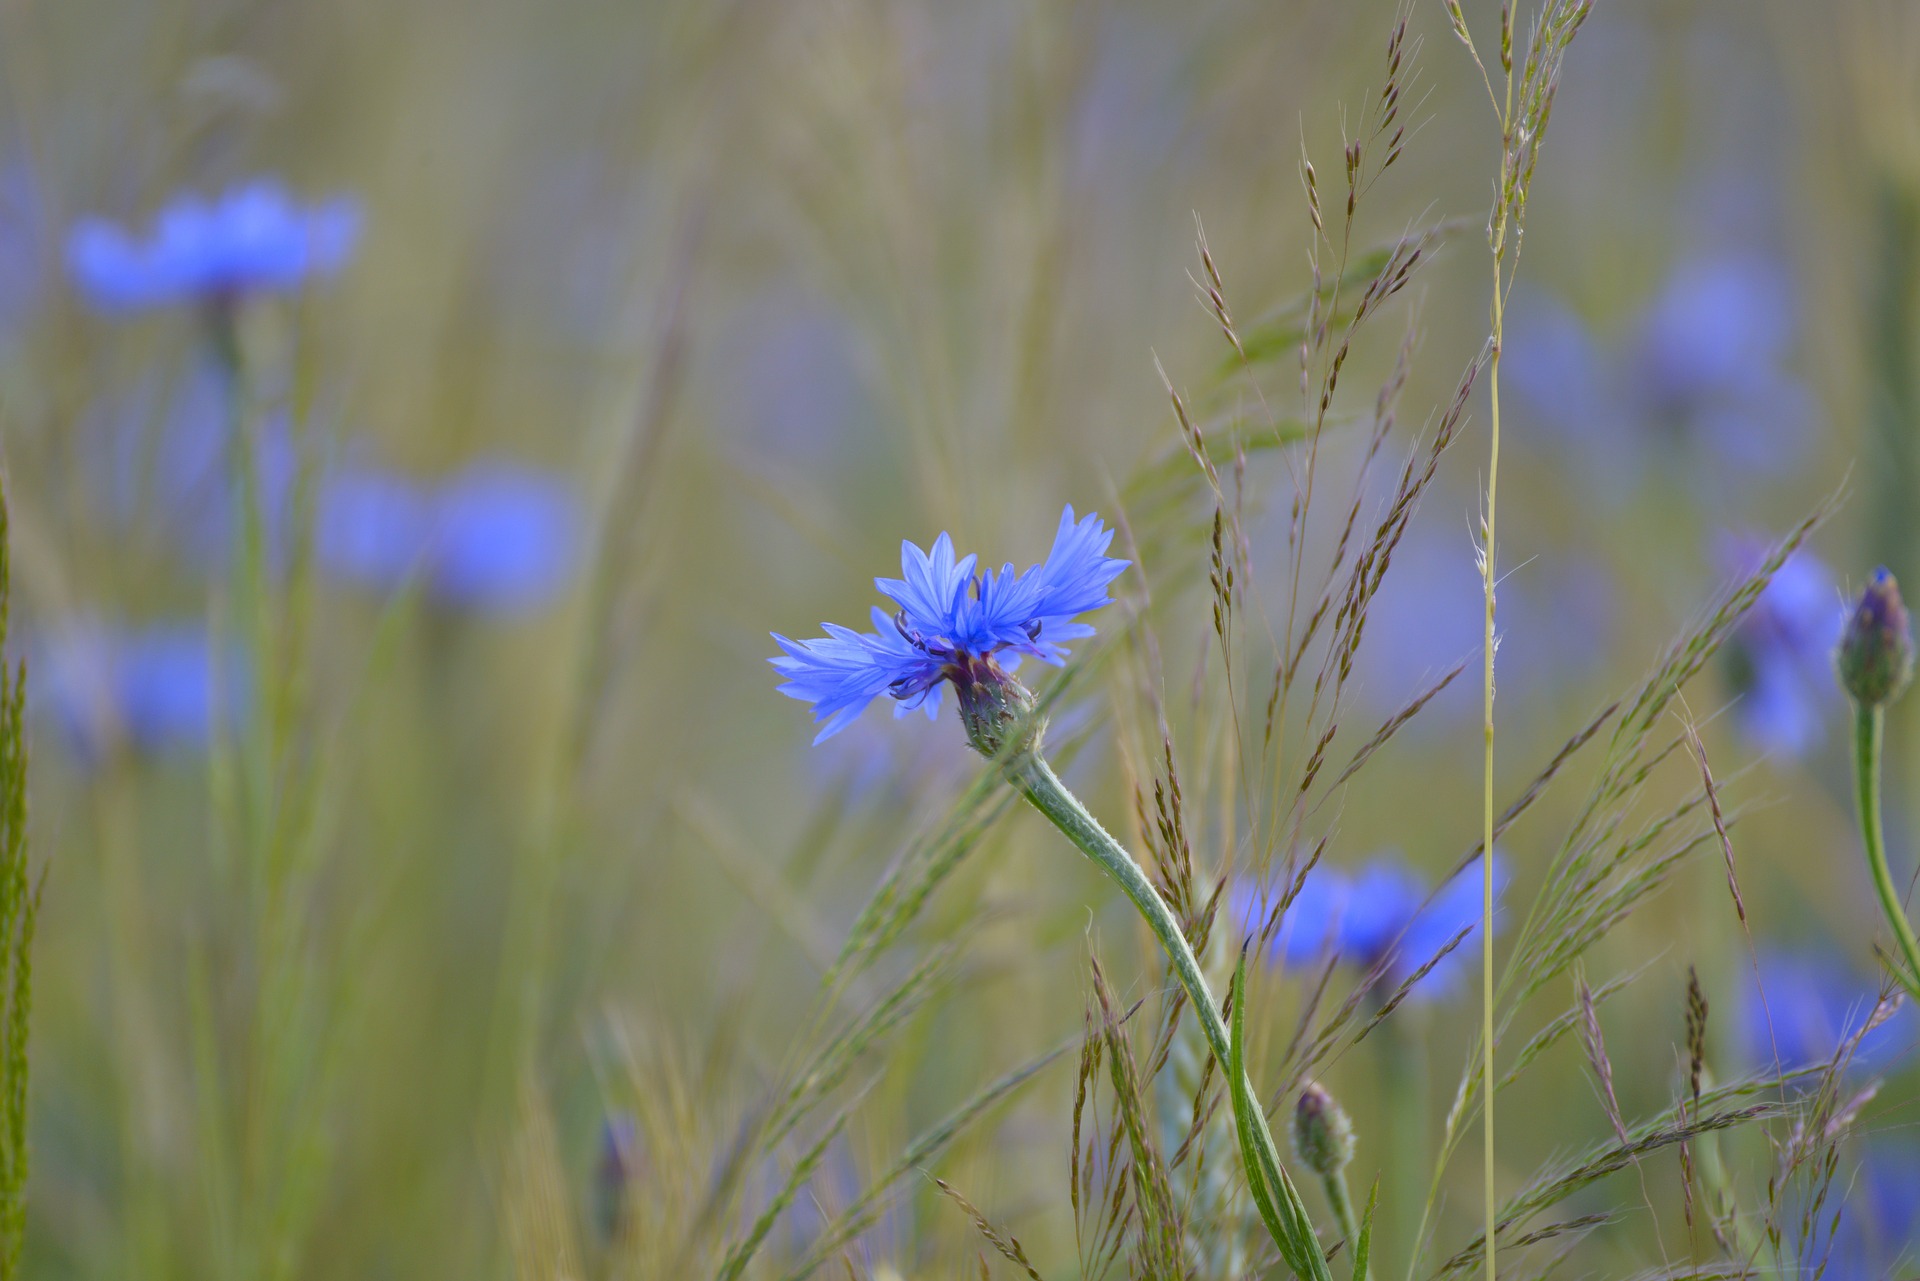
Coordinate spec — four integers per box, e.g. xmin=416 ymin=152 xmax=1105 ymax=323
xmin=1231 ymin=851 xmax=1507 ymax=1003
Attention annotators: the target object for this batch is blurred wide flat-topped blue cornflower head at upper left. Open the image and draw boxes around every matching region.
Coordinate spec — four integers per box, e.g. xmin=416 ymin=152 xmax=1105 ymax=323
xmin=67 ymin=179 xmax=361 ymax=311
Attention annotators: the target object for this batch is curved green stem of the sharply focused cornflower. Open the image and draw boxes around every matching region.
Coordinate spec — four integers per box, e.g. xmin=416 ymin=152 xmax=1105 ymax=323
xmin=1006 ymin=747 xmax=1357 ymax=1275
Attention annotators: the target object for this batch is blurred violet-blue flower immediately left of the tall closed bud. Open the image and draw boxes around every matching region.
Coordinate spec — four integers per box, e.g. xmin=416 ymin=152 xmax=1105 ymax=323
xmin=1720 ymin=536 xmax=1847 ymax=757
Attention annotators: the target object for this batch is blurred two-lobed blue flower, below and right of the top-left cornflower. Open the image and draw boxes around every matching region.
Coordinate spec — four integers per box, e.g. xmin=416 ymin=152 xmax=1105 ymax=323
xmin=315 ymin=459 xmax=582 ymax=613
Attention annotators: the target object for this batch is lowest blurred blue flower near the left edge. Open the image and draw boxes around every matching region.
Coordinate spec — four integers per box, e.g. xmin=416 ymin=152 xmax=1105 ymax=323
xmin=29 ymin=622 xmax=244 ymax=761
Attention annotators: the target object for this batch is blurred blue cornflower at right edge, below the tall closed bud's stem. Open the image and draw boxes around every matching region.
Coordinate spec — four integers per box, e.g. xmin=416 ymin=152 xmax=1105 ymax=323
xmin=1738 ymin=951 xmax=1920 ymax=1072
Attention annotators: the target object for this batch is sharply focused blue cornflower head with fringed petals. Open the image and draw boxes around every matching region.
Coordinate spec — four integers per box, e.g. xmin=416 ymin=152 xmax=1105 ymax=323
xmin=768 ymin=505 xmax=1127 ymax=755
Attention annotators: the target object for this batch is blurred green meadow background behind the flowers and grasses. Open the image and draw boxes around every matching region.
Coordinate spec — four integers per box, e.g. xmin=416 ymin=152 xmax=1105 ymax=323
xmin=0 ymin=0 xmax=1920 ymax=1281
